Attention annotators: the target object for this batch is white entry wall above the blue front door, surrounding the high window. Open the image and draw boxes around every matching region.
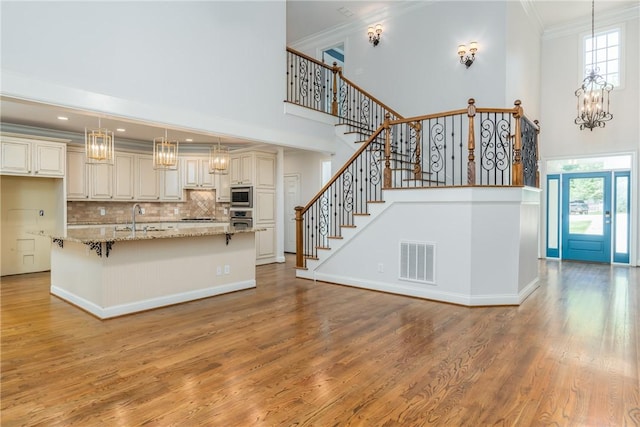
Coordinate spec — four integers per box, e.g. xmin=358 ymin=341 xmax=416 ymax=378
xmin=540 ymin=7 xmax=640 ymax=263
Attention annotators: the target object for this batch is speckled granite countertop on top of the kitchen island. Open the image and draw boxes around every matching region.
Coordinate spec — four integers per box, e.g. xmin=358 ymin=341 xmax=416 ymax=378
xmin=32 ymin=226 xmax=266 ymax=243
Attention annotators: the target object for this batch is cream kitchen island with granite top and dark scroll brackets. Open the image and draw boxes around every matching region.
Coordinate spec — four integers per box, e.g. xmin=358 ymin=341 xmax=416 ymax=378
xmin=38 ymin=226 xmax=261 ymax=319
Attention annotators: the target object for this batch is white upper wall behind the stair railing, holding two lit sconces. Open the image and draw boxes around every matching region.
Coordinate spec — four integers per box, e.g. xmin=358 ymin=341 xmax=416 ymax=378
xmin=293 ymin=1 xmax=539 ymax=119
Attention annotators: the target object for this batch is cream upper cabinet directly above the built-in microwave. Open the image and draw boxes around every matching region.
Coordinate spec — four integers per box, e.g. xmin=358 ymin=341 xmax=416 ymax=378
xmin=230 ymin=151 xmax=276 ymax=188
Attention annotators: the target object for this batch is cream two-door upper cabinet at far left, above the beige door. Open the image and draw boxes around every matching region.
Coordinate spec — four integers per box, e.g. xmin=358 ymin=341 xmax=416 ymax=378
xmin=0 ymin=134 xmax=67 ymax=178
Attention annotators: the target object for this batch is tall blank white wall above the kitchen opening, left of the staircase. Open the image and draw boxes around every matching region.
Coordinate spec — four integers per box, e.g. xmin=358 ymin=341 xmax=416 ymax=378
xmin=1 ymin=0 xmax=334 ymax=151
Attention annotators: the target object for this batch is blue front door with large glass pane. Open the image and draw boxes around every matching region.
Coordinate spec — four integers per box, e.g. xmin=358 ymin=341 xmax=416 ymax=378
xmin=562 ymin=172 xmax=611 ymax=263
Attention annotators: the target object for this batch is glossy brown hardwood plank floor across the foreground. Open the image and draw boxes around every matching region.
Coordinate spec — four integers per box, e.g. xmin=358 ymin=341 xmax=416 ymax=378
xmin=1 ymin=256 xmax=640 ymax=427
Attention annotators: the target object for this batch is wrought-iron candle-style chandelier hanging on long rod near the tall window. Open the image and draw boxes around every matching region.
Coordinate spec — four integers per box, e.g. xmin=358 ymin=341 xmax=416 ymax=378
xmin=574 ymin=0 xmax=613 ymax=131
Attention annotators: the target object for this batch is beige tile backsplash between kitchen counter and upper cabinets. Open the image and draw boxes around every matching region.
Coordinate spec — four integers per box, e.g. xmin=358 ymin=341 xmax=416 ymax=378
xmin=67 ymin=190 xmax=229 ymax=224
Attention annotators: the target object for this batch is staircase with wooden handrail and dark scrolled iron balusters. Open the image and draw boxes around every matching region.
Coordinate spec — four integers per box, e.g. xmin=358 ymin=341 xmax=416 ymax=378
xmin=287 ymin=49 xmax=539 ymax=294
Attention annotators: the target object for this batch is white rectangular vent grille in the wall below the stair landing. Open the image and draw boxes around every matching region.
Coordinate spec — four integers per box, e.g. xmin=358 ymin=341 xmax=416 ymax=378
xmin=400 ymin=241 xmax=436 ymax=284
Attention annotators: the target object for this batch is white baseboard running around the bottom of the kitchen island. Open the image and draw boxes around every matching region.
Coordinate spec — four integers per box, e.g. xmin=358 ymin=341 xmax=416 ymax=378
xmin=51 ymin=280 xmax=256 ymax=319
